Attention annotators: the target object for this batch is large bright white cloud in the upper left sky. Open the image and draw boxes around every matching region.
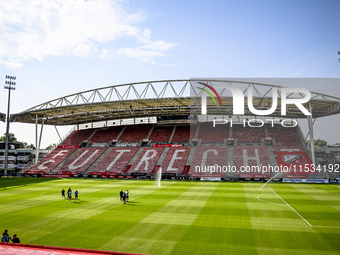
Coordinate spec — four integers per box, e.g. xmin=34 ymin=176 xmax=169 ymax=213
xmin=0 ymin=0 xmax=174 ymax=68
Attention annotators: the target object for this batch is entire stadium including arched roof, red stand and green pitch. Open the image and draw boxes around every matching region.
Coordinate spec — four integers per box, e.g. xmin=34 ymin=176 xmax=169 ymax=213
xmin=0 ymin=79 xmax=340 ymax=254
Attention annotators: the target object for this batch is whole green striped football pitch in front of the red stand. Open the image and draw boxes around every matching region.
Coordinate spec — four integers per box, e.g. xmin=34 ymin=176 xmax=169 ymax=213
xmin=0 ymin=178 xmax=340 ymax=254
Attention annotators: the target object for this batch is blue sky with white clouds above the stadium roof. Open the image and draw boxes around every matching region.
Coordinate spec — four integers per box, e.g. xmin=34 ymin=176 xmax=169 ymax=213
xmin=0 ymin=0 xmax=340 ymax=148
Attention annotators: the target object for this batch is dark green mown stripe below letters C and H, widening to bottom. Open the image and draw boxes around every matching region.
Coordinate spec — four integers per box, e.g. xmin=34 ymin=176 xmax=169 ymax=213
xmin=173 ymin=183 xmax=255 ymax=254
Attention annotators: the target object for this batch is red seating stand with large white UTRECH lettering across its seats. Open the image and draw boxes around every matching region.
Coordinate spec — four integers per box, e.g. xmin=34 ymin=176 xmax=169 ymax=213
xmin=24 ymin=123 xmax=311 ymax=178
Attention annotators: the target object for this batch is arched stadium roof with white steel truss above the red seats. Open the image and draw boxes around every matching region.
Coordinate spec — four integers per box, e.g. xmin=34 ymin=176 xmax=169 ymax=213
xmin=11 ymin=79 xmax=340 ymax=125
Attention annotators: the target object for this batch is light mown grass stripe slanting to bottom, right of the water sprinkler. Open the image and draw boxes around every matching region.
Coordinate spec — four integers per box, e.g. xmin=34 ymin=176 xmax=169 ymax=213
xmin=103 ymin=183 xmax=216 ymax=254
